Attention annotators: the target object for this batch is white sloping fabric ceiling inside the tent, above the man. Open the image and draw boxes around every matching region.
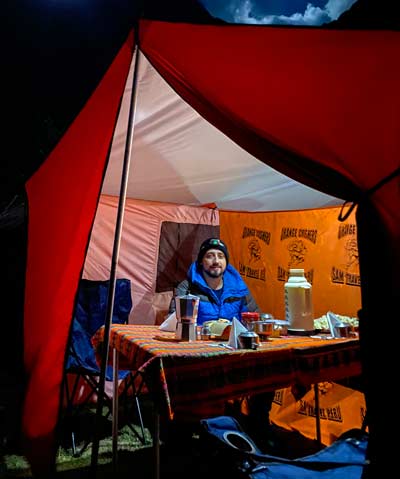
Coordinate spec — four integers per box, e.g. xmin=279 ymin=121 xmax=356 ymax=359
xmin=102 ymin=50 xmax=343 ymax=211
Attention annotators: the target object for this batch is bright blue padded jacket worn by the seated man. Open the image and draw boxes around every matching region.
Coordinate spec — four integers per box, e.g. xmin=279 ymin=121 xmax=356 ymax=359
xmin=170 ymin=262 xmax=260 ymax=324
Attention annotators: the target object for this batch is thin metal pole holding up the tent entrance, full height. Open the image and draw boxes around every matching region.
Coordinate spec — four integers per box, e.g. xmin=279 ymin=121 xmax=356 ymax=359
xmin=90 ymin=43 xmax=140 ymax=478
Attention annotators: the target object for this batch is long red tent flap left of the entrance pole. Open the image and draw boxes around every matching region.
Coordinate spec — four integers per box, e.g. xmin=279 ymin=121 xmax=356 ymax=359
xmin=23 ymin=35 xmax=132 ymax=477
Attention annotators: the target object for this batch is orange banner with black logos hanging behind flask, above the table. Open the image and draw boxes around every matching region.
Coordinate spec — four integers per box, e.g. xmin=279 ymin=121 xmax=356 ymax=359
xmin=220 ymin=207 xmax=361 ymax=319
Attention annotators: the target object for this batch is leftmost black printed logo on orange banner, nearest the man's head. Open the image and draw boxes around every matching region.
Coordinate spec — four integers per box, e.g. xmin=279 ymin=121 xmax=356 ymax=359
xmin=239 ymin=226 xmax=271 ymax=281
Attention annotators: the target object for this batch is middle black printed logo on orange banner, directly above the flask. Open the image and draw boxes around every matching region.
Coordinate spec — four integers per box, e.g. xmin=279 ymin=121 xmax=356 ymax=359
xmin=277 ymin=226 xmax=318 ymax=284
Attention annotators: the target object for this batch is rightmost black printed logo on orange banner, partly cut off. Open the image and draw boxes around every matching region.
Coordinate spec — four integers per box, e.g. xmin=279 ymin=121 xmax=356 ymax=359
xmin=331 ymin=223 xmax=361 ymax=286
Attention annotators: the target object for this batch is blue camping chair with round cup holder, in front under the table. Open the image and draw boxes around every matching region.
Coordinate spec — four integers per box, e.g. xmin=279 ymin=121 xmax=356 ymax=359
xmin=200 ymin=416 xmax=369 ymax=479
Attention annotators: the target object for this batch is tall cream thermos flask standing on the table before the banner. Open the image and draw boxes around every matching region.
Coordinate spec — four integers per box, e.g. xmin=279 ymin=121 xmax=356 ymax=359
xmin=285 ymin=269 xmax=314 ymax=336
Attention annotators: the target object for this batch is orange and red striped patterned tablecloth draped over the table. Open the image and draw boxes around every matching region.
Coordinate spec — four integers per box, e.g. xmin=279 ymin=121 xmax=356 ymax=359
xmin=92 ymin=325 xmax=361 ymax=420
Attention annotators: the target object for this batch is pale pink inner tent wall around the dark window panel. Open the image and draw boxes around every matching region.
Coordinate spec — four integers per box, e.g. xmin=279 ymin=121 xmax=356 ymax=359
xmin=83 ymin=195 xmax=219 ymax=324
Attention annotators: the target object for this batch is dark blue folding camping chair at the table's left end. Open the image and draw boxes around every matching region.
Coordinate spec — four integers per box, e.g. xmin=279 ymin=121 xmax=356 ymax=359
xmin=64 ymin=279 xmax=145 ymax=456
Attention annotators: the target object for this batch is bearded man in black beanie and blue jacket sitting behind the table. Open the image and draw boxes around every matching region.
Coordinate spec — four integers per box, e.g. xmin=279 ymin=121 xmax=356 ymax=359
xmin=169 ymin=238 xmax=274 ymax=448
